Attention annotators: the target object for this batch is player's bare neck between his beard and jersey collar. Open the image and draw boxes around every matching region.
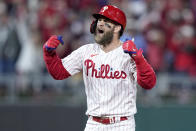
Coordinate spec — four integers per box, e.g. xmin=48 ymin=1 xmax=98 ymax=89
xmin=101 ymin=38 xmax=122 ymax=53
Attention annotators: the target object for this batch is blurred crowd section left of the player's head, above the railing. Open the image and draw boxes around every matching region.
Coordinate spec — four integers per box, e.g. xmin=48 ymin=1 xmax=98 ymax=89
xmin=0 ymin=0 xmax=105 ymax=74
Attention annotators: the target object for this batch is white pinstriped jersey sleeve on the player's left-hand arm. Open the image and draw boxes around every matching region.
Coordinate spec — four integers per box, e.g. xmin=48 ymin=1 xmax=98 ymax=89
xmin=61 ymin=45 xmax=87 ymax=75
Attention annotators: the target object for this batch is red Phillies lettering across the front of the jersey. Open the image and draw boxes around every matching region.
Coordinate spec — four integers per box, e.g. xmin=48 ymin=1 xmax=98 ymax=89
xmin=84 ymin=59 xmax=127 ymax=79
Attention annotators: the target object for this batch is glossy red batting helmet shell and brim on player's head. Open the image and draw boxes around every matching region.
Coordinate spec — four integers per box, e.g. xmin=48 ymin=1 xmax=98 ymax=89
xmin=93 ymin=5 xmax=126 ymax=30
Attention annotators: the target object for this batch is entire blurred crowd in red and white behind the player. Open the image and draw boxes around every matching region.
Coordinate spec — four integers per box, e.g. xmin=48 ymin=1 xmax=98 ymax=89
xmin=0 ymin=0 xmax=196 ymax=103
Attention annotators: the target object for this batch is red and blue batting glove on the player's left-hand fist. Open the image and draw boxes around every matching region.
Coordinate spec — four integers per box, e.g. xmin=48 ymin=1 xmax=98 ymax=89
xmin=44 ymin=35 xmax=64 ymax=51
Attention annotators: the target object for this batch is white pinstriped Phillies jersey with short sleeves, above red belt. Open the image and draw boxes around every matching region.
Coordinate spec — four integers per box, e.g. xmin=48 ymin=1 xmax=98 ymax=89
xmin=62 ymin=43 xmax=137 ymax=116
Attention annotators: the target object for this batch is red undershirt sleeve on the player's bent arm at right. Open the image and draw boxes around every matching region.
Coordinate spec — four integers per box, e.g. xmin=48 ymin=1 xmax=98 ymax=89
xmin=136 ymin=57 xmax=156 ymax=89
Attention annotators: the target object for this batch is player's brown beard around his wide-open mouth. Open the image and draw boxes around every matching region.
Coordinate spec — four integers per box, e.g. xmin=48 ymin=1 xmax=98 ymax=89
xmin=94 ymin=28 xmax=114 ymax=46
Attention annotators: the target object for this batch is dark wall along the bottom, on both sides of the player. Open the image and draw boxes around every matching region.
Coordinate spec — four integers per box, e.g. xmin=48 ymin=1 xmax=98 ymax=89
xmin=0 ymin=105 xmax=196 ymax=131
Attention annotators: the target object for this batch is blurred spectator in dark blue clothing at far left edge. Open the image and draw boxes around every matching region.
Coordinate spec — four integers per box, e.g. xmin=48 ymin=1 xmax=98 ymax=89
xmin=0 ymin=1 xmax=21 ymax=73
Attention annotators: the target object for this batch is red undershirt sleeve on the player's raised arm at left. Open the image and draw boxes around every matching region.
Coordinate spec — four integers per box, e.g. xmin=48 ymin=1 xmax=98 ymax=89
xmin=43 ymin=48 xmax=71 ymax=80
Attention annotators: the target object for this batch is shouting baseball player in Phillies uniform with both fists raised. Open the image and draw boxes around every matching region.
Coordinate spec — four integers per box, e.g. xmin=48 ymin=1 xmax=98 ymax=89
xmin=43 ymin=5 xmax=156 ymax=131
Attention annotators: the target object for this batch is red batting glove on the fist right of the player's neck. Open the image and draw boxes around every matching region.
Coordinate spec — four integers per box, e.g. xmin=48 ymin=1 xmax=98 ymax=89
xmin=122 ymin=40 xmax=143 ymax=61
